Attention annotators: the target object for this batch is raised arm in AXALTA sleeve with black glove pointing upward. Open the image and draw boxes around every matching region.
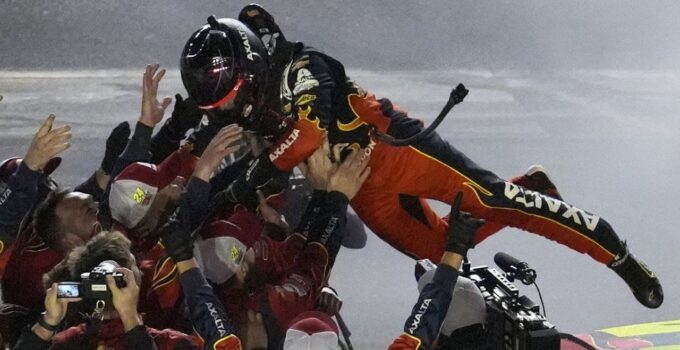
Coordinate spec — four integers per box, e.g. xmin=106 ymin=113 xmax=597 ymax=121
xmin=389 ymin=192 xmax=484 ymax=350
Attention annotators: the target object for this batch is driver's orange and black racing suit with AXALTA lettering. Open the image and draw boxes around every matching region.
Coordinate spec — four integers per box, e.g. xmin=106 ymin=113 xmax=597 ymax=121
xmin=230 ymin=44 xmax=623 ymax=263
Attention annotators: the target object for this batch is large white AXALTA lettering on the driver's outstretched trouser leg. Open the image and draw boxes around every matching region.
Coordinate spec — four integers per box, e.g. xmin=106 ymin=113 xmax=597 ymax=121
xmin=504 ymin=182 xmax=600 ymax=231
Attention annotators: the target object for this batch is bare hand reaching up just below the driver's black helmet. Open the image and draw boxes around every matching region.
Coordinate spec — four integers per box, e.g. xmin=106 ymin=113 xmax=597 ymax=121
xmin=194 ymin=124 xmax=243 ymax=182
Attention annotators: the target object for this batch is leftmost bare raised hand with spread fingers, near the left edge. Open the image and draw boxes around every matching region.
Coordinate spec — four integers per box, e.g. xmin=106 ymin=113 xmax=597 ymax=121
xmin=24 ymin=114 xmax=71 ymax=171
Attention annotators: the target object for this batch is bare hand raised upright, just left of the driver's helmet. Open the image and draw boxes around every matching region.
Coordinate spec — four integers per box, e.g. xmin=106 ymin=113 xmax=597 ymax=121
xmin=139 ymin=63 xmax=172 ymax=128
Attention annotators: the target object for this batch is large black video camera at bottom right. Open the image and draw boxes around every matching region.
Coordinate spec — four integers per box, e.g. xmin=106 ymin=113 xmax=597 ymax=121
xmin=462 ymin=266 xmax=560 ymax=350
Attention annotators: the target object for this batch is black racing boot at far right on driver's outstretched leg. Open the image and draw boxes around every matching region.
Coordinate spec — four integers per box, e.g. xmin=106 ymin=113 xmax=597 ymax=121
xmin=607 ymin=242 xmax=663 ymax=309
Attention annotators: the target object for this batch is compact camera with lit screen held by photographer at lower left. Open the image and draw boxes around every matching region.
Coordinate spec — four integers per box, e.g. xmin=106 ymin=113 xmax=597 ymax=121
xmin=57 ymin=260 xmax=127 ymax=301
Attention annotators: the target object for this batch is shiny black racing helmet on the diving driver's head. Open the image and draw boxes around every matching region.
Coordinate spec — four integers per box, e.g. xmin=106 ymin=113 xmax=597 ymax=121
xmin=179 ymin=16 xmax=269 ymax=127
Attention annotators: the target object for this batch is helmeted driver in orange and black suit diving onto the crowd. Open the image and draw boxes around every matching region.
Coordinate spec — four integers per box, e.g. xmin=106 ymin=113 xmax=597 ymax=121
xmin=180 ymin=5 xmax=663 ymax=308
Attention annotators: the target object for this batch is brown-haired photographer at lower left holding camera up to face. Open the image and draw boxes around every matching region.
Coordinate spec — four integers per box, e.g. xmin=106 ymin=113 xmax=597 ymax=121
xmin=14 ymin=231 xmax=198 ymax=349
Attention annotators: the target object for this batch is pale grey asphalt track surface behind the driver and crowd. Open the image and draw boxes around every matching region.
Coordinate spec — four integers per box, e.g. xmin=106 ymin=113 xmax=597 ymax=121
xmin=0 ymin=67 xmax=680 ymax=349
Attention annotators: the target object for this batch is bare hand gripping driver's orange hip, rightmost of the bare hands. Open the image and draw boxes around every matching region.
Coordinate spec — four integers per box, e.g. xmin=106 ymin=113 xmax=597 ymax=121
xmin=328 ymin=149 xmax=371 ymax=200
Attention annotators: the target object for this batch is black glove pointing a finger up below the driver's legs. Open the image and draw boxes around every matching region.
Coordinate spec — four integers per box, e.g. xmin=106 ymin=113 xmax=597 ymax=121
xmin=446 ymin=192 xmax=485 ymax=256
